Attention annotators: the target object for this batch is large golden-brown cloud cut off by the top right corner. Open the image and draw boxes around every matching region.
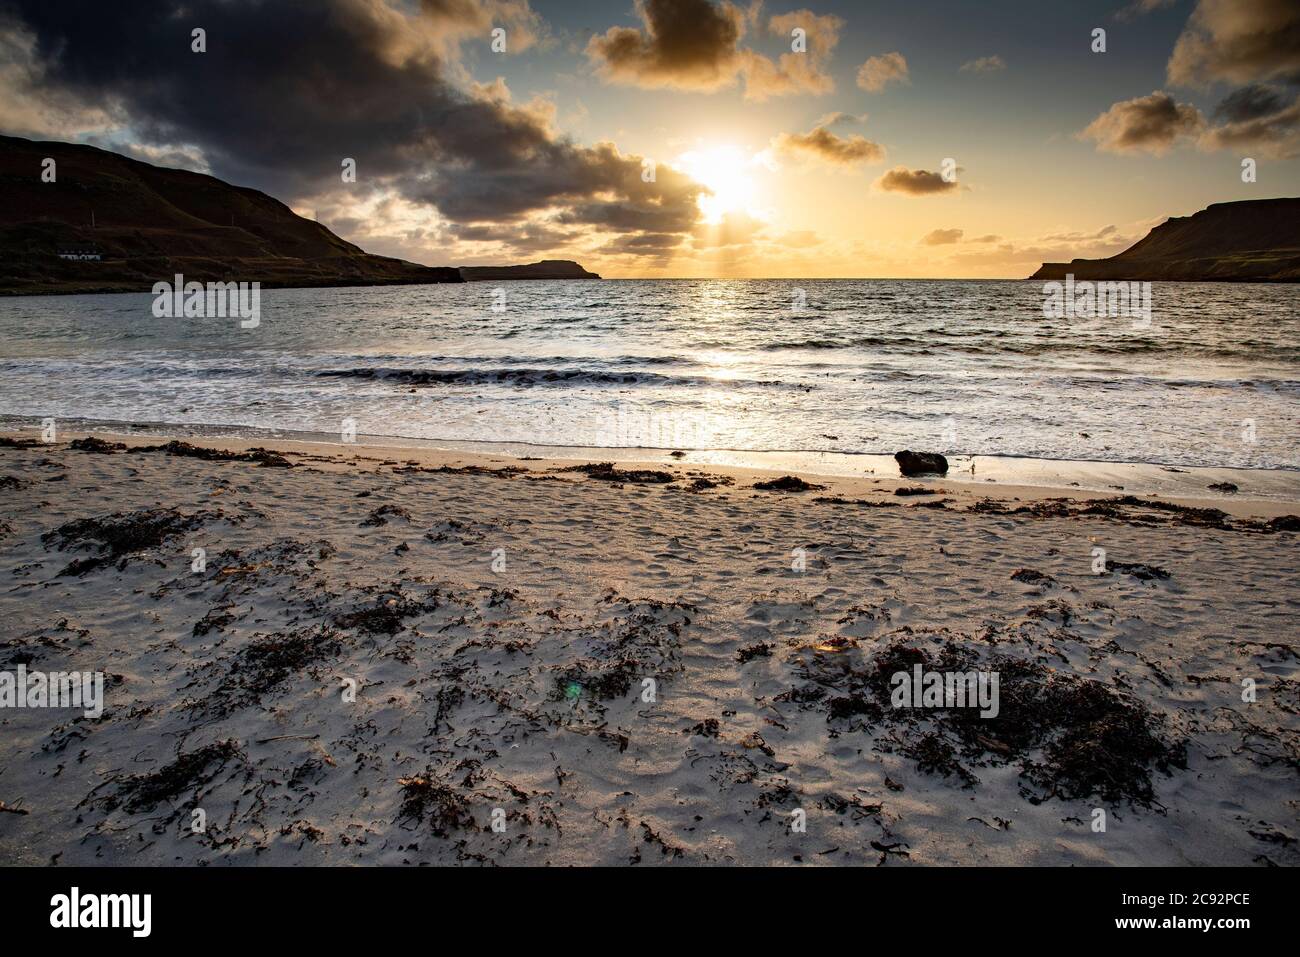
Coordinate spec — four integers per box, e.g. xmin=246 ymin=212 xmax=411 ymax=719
xmin=1166 ymin=0 xmax=1300 ymax=88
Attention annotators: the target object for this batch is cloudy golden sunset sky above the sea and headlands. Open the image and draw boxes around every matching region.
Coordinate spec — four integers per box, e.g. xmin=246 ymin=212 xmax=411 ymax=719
xmin=0 ymin=0 xmax=1300 ymax=278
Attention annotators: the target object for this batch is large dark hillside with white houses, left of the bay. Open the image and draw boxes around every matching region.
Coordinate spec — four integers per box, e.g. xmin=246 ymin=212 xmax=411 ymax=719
xmin=0 ymin=137 xmax=463 ymax=295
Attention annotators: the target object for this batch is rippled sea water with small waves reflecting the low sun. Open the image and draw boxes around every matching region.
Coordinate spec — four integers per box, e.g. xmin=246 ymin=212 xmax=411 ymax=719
xmin=0 ymin=280 xmax=1300 ymax=469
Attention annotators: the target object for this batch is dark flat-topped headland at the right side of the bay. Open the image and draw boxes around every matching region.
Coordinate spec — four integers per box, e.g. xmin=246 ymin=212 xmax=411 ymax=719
xmin=1030 ymin=199 xmax=1300 ymax=282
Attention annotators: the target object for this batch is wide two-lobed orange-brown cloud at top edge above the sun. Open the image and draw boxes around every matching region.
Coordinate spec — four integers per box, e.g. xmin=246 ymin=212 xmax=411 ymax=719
xmin=586 ymin=0 xmax=844 ymax=100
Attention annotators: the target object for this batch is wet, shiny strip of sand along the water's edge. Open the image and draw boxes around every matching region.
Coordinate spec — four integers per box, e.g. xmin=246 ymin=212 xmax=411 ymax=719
xmin=0 ymin=420 xmax=1300 ymax=519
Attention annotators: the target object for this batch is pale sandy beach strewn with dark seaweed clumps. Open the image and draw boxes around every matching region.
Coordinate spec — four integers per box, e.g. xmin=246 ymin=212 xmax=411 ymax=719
xmin=0 ymin=432 xmax=1300 ymax=866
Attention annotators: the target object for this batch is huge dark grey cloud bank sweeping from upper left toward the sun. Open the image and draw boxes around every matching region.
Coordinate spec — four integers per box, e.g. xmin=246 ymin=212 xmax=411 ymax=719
xmin=0 ymin=0 xmax=703 ymax=261
